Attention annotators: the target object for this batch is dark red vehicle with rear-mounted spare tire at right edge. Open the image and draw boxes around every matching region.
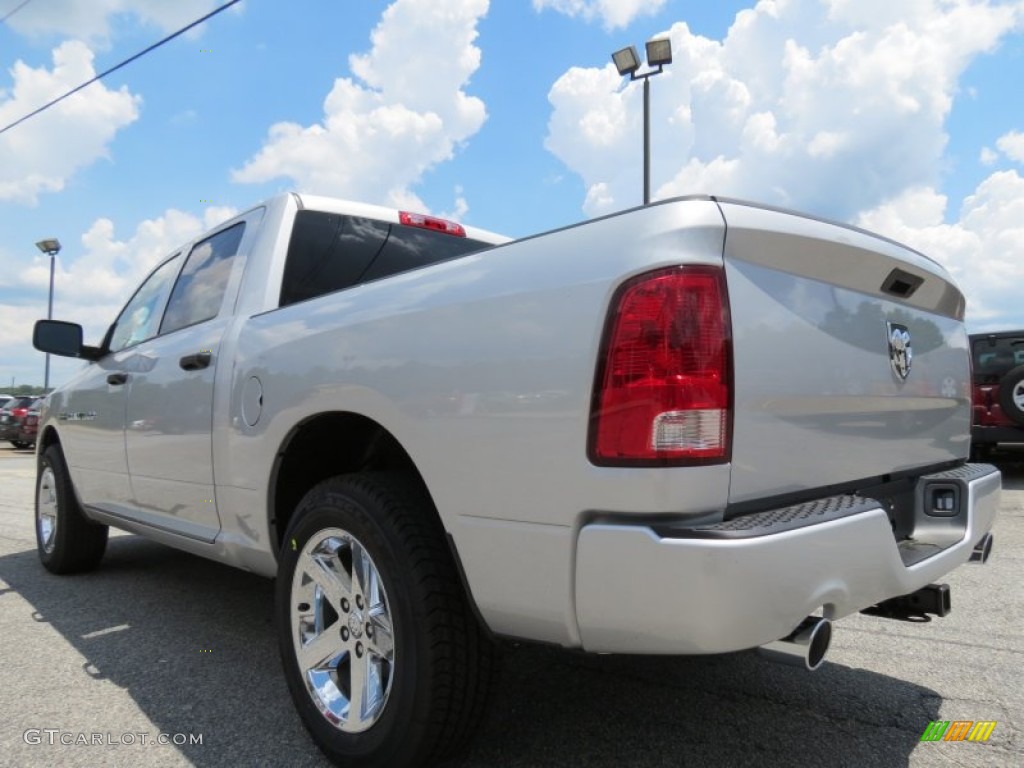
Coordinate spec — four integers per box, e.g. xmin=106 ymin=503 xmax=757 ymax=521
xmin=971 ymin=331 xmax=1024 ymax=457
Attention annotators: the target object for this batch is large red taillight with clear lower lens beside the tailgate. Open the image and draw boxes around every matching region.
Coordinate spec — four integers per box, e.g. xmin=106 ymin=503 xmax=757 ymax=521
xmin=589 ymin=266 xmax=732 ymax=466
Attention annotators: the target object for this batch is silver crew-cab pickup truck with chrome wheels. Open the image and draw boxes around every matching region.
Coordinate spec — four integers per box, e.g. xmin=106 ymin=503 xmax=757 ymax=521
xmin=34 ymin=195 xmax=1000 ymax=766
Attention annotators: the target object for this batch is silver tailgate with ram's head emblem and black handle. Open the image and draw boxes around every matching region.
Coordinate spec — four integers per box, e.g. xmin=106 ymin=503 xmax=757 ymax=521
xmin=720 ymin=201 xmax=971 ymax=504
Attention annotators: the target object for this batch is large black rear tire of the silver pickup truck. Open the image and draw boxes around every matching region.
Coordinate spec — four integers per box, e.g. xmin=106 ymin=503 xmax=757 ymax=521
xmin=275 ymin=473 xmax=495 ymax=768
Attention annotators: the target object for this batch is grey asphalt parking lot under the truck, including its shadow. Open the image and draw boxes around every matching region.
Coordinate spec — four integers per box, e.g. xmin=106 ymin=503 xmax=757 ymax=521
xmin=0 ymin=444 xmax=1024 ymax=766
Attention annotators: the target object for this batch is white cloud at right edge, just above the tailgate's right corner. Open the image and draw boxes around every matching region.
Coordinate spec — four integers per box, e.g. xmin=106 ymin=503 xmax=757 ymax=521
xmin=856 ymin=171 xmax=1024 ymax=331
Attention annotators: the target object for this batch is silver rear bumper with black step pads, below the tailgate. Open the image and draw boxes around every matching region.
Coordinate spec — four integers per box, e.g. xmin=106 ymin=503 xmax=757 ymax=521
xmin=575 ymin=464 xmax=1000 ymax=653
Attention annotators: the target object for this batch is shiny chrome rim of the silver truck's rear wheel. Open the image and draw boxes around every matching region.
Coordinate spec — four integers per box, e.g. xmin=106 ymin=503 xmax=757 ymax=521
xmin=294 ymin=528 xmax=395 ymax=733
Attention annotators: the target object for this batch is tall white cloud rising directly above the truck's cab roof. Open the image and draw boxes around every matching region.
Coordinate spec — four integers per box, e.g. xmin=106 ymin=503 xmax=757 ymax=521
xmin=232 ymin=0 xmax=488 ymax=210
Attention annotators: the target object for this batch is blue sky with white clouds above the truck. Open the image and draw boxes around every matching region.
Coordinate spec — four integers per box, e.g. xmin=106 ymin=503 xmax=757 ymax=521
xmin=0 ymin=0 xmax=1024 ymax=390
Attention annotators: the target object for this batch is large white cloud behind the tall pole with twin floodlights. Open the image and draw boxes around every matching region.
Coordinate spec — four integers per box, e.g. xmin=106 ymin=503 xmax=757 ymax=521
xmin=546 ymin=0 xmax=1024 ymax=219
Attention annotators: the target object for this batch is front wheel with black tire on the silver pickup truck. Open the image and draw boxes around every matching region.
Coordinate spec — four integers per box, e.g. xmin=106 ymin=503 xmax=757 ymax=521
xmin=36 ymin=444 xmax=110 ymax=573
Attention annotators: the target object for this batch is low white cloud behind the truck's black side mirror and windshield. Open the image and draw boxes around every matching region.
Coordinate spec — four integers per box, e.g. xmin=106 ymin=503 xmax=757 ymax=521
xmin=0 ymin=207 xmax=236 ymax=384
